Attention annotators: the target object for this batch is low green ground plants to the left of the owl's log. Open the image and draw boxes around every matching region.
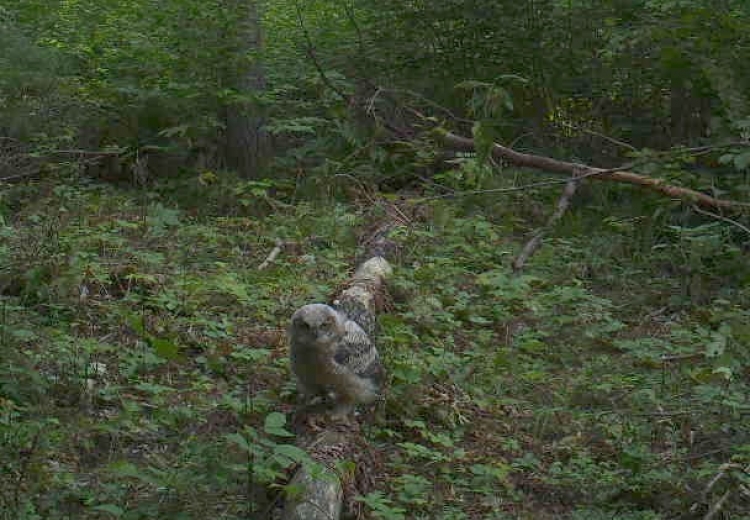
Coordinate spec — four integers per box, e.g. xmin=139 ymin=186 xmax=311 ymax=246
xmin=0 ymin=179 xmax=358 ymax=519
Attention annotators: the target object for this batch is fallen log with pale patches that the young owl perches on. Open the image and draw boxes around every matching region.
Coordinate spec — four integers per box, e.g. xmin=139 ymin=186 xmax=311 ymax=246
xmin=282 ymin=225 xmax=397 ymax=520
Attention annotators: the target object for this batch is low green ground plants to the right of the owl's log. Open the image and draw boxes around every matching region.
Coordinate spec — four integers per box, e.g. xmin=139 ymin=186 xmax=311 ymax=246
xmin=370 ymin=202 xmax=748 ymax=518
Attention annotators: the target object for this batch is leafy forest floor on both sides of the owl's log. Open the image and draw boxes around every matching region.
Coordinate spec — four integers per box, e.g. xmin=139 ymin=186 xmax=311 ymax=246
xmin=0 ymin=176 xmax=750 ymax=520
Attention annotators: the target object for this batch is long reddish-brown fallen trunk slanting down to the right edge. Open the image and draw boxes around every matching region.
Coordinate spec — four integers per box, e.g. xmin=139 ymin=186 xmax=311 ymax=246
xmin=442 ymin=132 xmax=750 ymax=213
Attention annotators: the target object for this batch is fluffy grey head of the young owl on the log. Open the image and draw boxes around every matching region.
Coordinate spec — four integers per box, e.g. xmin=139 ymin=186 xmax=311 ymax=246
xmin=289 ymin=303 xmax=346 ymax=354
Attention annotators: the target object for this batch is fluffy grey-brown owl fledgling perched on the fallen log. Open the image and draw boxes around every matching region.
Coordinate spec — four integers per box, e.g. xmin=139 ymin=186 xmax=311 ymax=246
xmin=289 ymin=303 xmax=384 ymax=416
